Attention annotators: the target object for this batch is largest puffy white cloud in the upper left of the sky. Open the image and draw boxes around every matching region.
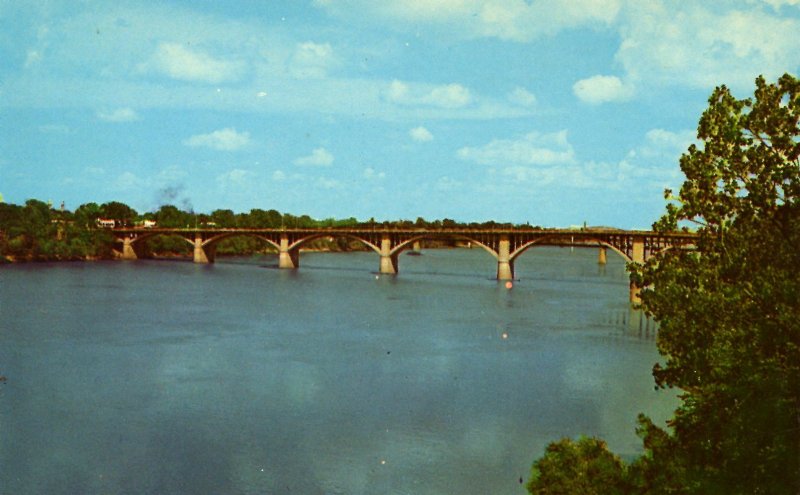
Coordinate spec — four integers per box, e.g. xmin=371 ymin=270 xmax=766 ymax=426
xmin=146 ymin=43 xmax=244 ymax=84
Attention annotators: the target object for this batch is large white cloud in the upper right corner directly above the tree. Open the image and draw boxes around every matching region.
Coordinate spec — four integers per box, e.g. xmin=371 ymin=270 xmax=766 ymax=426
xmin=616 ymin=2 xmax=800 ymax=91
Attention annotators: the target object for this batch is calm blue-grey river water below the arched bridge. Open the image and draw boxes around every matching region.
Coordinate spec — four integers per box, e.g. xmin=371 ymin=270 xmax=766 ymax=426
xmin=0 ymin=248 xmax=675 ymax=495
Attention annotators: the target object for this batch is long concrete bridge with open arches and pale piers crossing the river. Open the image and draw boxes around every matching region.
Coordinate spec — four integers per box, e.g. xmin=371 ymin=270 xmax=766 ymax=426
xmin=111 ymin=228 xmax=696 ymax=301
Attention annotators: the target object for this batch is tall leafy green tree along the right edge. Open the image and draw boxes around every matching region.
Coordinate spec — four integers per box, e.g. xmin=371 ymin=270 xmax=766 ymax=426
xmin=532 ymin=75 xmax=800 ymax=494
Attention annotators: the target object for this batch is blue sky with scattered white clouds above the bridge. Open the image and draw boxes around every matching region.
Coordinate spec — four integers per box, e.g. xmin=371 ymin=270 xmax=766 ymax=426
xmin=0 ymin=0 xmax=800 ymax=229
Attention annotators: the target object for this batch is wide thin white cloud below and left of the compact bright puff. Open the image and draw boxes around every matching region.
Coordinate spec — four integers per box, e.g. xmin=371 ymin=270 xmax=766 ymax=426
xmin=457 ymin=130 xmax=575 ymax=166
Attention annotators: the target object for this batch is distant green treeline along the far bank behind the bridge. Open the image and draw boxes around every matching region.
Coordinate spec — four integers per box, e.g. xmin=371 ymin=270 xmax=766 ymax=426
xmin=0 ymin=199 xmax=538 ymax=261
